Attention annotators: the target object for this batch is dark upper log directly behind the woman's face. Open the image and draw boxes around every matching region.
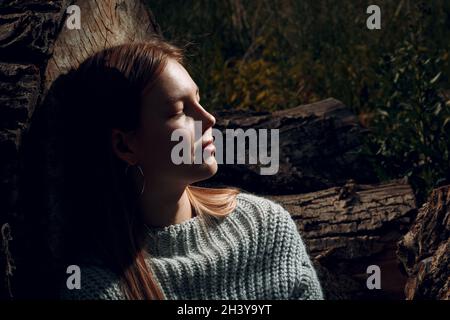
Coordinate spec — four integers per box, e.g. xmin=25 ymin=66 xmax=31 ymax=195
xmin=201 ymin=98 xmax=377 ymax=194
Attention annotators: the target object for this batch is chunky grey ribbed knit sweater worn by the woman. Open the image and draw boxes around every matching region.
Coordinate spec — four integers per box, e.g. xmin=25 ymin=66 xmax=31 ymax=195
xmin=62 ymin=193 xmax=323 ymax=300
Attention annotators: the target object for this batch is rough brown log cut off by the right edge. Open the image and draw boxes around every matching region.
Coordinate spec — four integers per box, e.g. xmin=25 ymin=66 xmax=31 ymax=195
xmin=398 ymin=186 xmax=450 ymax=300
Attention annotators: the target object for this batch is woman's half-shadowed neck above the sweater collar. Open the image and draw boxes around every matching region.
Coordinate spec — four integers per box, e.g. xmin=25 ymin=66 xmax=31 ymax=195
xmin=140 ymin=182 xmax=193 ymax=227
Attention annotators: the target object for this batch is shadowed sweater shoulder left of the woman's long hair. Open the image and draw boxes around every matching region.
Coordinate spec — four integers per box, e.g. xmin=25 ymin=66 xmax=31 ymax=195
xmin=60 ymin=265 xmax=125 ymax=300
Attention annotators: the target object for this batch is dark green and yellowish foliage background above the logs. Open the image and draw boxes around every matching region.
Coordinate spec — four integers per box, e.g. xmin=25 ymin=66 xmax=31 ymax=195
xmin=148 ymin=0 xmax=450 ymax=199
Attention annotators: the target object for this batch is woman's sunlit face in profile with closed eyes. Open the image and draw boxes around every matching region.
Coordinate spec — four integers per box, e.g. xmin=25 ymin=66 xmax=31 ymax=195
xmin=125 ymin=59 xmax=217 ymax=185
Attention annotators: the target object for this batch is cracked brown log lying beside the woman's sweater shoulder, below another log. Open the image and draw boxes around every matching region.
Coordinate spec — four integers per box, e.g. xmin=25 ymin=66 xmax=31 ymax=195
xmin=270 ymin=180 xmax=416 ymax=299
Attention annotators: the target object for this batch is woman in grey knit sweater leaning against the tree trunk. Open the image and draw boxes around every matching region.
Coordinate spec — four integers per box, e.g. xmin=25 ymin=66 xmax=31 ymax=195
xmin=58 ymin=38 xmax=322 ymax=299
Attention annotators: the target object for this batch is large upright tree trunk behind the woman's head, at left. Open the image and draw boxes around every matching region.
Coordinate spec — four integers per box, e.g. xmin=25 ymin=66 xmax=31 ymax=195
xmin=0 ymin=0 xmax=160 ymax=299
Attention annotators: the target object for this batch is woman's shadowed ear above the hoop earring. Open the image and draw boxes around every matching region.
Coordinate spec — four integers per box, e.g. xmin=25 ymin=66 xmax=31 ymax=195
xmin=111 ymin=129 xmax=138 ymax=165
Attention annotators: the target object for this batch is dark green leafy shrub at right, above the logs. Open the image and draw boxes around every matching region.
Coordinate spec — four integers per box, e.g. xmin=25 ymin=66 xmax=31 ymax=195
xmin=368 ymin=6 xmax=450 ymax=202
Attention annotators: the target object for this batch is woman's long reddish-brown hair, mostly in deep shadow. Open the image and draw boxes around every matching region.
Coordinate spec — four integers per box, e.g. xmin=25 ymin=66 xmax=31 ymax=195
xmin=62 ymin=38 xmax=239 ymax=299
